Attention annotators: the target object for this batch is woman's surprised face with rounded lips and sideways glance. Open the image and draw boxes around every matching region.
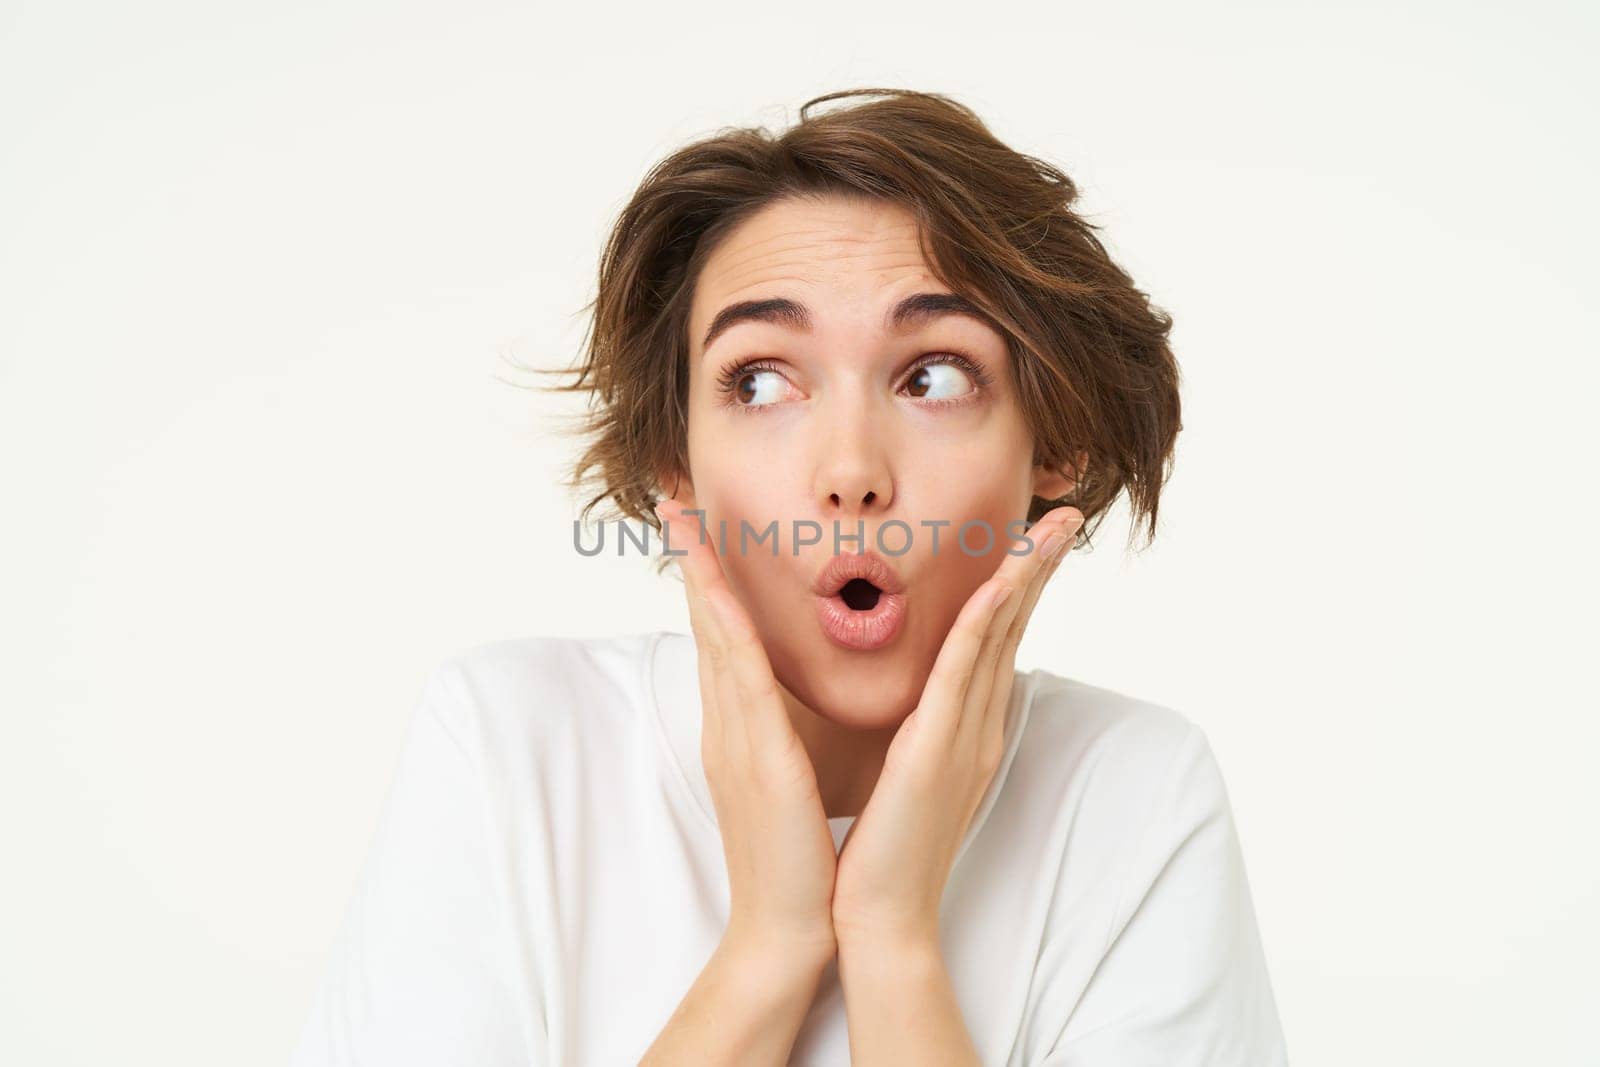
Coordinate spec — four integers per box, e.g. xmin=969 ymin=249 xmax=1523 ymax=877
xmin=664 ymin=198 xmax=1070 ymax=729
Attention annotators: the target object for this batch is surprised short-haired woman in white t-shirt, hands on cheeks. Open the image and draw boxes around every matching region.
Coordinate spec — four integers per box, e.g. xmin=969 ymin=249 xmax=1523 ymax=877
xmin=296 ymin=91 xmax=1285 ymax=1067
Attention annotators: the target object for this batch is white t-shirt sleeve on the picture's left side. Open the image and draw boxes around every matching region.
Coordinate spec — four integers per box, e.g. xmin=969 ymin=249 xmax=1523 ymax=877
xmin=291 ymin=662 xmax=539 ymax=1067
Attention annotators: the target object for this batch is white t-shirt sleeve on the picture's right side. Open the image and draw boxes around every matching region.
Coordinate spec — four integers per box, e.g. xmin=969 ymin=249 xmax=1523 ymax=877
xmin=1040 ymin=725 xmax=1288 ymax=1067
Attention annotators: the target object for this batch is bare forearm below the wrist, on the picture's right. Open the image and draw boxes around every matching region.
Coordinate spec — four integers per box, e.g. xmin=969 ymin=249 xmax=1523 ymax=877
xmin=838 ymin=937 xmax=982 ymax=1067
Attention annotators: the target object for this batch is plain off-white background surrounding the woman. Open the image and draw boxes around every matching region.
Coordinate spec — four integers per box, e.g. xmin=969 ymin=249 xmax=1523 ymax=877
xmin=0 ymin=0 xmax=1600 ymax=1067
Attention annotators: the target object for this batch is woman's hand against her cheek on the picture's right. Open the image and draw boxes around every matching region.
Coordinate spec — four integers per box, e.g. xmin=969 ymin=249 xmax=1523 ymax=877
xmin=832 ymin=507 xmax=1083 ymax=949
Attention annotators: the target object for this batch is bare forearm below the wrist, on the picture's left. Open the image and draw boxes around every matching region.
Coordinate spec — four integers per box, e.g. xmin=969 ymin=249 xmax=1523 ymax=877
xmin=640 ymin=937 xmax=830 ymax=1067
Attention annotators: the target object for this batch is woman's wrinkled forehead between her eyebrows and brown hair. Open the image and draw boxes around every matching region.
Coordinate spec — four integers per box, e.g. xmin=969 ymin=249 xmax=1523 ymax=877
xmin=690 ymin=197 xmax=946 ymax=338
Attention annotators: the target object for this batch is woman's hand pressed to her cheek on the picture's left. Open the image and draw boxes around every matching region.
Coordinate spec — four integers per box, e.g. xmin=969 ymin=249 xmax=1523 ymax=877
xmin=656 ymin=499 xmax=838 ymax=961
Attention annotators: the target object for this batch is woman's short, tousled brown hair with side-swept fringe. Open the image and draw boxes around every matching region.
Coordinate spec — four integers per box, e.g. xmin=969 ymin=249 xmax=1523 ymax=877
xmin=524 ymin=90 xmax=1182 ymax=566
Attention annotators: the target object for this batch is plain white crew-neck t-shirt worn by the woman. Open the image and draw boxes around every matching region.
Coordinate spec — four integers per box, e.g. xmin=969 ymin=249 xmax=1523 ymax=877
xmin=294 ymin=632 xmax=1286 ymax=1067
